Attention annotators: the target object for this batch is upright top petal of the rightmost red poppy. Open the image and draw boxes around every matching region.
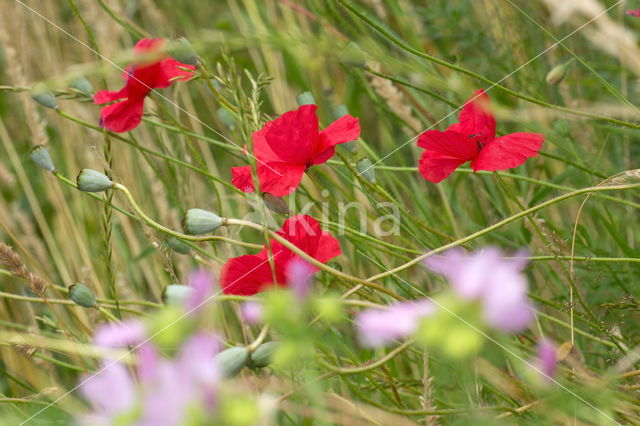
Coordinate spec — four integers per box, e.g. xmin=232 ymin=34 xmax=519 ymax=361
xmin=458 ymin=89 xmax=496 ymax=143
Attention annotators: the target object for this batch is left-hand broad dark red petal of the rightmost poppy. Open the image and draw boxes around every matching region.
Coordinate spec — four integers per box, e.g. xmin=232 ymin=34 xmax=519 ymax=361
xmin=418 ymin=130 xmax=478 ymax=183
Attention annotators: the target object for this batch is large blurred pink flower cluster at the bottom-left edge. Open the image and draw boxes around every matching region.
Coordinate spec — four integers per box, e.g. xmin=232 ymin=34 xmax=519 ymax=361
xmin=79 ymin=332 xmax=220 ymax=426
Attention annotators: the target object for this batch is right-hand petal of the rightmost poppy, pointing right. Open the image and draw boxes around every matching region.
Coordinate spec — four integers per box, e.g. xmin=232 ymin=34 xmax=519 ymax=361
xmin=471 ymin=132 xmax=544 ymax=172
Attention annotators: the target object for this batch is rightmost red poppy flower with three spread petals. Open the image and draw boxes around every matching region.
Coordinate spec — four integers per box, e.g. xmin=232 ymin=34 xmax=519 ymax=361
xmin=418 ymin=90 xmax=544 ymax=183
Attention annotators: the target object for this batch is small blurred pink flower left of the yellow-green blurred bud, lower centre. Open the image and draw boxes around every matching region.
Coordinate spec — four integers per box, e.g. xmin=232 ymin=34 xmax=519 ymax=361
xmin=355 ymin=300 xmax=435 ymax=347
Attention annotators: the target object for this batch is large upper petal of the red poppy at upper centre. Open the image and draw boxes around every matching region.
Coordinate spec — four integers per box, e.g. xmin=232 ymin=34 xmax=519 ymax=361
xmin=254 ymin=105 xmax=319 ymax=166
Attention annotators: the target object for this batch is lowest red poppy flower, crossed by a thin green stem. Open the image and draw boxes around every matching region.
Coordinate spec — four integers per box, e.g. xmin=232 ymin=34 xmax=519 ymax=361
xmin=220 ymin=215 xmax=342 ymax=296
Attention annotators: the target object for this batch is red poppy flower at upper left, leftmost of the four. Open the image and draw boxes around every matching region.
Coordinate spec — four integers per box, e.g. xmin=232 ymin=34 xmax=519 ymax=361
xmin=93 ymin=38 xmax=195 ymax=133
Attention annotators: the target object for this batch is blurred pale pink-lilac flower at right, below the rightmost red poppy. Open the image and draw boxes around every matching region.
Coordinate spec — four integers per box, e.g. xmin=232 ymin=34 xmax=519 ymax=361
xmin=425 ymin=247 xmax=533 ymax=332
